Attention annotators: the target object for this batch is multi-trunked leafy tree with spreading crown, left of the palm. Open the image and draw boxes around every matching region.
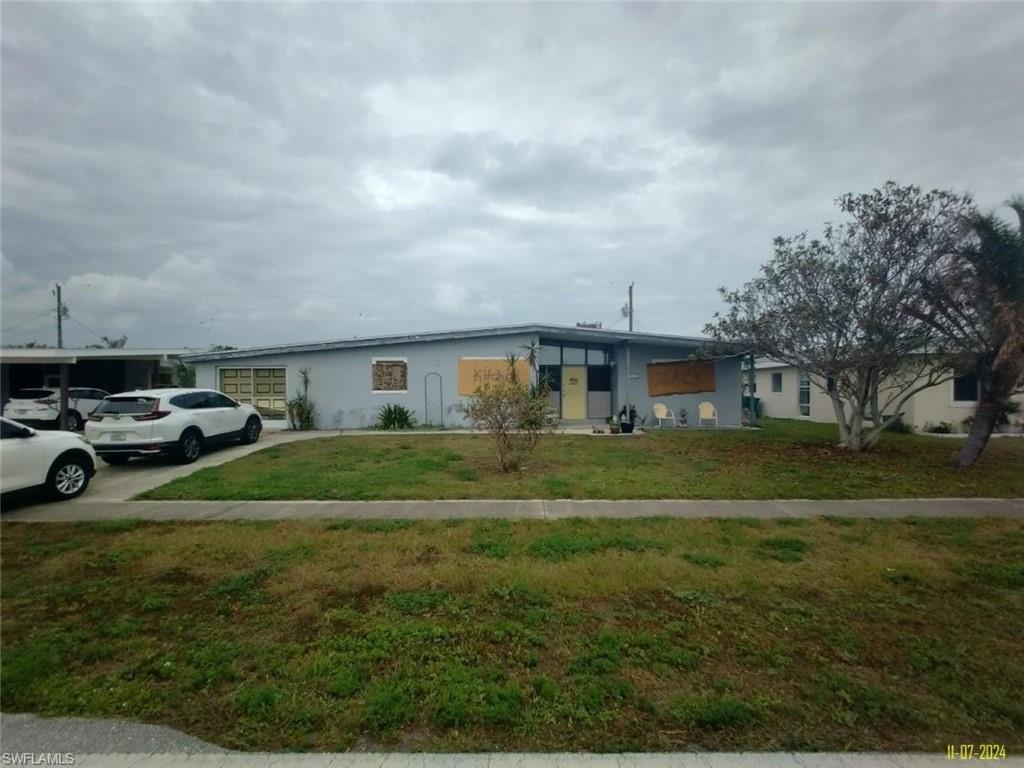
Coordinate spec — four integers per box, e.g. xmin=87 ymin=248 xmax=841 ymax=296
xmin=705 ymin=181 xmax=973 ymax=451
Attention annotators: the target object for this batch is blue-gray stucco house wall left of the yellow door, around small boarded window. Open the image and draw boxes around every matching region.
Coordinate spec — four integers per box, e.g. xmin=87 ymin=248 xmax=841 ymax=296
xmin=196 ymin=335 xmax=531 ymax=429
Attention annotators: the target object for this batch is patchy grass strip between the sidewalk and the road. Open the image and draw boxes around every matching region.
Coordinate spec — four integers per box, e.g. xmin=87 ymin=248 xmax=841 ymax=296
xmin=0 ymin=518 xmax=1024 ymax=752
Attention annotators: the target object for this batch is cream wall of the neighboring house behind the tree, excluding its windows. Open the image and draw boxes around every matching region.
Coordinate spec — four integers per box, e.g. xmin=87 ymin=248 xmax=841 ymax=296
xmin=756 ymin=360 xmax=1024 ymax=432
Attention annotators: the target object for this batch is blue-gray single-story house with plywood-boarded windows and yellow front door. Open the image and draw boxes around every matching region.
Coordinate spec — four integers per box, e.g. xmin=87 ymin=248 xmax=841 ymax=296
xmin=182 ymin=325 xmax=741 ymax=428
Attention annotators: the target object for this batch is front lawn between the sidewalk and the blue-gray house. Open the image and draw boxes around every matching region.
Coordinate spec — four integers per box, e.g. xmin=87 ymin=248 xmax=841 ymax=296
xmin=140 ymin=419 xmax=1024 ymax=501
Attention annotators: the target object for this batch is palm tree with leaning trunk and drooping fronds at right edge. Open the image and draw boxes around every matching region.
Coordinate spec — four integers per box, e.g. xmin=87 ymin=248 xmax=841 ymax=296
xmin=908 ymin=197 xmax=1024 ymax=467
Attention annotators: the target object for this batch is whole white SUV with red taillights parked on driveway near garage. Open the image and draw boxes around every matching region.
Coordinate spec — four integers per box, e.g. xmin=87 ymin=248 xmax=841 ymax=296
xmin=85 ymin=389 xmax=263 ymax=464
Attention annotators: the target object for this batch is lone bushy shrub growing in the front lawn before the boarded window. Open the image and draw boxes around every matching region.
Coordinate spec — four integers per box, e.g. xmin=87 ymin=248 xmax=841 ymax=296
xmin=460 ymin=353 xmax=553 ymax=472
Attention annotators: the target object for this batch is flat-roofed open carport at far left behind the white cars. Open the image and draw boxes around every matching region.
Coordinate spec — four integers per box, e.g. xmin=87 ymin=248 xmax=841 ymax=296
xmin=0 ymin=347 xmax=195 ymax=429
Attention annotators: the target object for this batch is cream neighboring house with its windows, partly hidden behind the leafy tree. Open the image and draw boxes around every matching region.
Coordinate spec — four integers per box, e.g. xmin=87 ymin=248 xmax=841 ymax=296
xmin=755 ymin=359 xmax=1024 ymax=432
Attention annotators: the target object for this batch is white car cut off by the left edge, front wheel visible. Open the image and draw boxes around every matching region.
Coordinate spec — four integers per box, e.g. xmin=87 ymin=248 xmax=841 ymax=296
xmin=0 ymin=419 xmax=96 ymax=501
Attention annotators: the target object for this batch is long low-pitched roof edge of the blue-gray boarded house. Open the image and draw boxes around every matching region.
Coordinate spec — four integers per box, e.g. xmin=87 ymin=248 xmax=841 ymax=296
xmin=181 ymin=324 xmax=733 ymax=362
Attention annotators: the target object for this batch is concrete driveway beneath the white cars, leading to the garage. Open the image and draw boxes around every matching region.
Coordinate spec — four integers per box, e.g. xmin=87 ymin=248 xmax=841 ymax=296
xmin=3 ymin=429 xmax=327 ymax=512
